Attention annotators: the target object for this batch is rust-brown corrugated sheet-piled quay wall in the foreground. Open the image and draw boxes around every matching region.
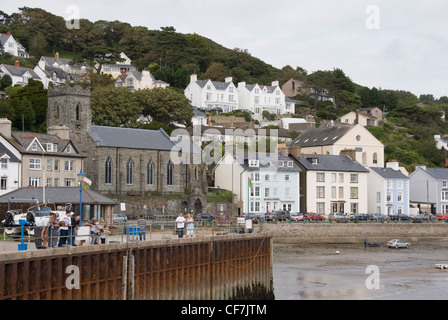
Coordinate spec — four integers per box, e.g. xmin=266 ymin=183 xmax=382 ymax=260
xmin=0 ymin=234 xmax=274 ymax=300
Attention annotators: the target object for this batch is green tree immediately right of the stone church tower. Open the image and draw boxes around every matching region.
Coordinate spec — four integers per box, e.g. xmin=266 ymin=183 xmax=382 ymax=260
xmin=91 ymin=87 xmax=142 ymax=128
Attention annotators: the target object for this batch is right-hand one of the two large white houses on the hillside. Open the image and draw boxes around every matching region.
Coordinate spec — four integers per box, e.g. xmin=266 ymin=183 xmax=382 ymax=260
xmin=238 ymin=81 xmax=295 ymax=121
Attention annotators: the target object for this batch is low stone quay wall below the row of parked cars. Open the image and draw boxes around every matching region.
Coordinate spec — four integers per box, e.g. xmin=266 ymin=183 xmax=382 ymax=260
xmin=257 ymin=222 xmax=448 ymax=244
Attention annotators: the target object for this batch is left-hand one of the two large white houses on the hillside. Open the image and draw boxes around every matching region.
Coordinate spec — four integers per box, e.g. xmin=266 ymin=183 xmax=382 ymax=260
xmin=184 ymin=74 xmax=238 ymax=112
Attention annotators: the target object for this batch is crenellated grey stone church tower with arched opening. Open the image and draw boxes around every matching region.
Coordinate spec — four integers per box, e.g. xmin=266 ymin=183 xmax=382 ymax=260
xmin=47 ymin=85 xmax=92 ymax=143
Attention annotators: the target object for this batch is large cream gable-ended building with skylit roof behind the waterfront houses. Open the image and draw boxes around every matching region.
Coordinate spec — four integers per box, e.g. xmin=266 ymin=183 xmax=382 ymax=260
xmin=289 ymin=122 xmax=384 ymax=168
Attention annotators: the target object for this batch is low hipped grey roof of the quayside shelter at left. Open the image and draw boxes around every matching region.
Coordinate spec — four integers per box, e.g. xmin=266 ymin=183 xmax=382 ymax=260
xmin=0 ymin=187 xmax=116 ymax=205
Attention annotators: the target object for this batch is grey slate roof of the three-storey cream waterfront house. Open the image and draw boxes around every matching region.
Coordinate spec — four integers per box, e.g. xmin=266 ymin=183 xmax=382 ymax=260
xmin=291 ymin=154 xmax=369 ymax=172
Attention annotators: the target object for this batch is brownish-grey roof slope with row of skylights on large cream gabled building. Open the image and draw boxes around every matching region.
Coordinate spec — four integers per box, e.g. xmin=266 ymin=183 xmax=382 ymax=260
xmin=290 ymin=124 xmax=354 ymax=147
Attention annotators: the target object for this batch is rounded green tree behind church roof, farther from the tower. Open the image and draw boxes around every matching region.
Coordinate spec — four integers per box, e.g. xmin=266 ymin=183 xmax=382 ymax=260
xmin=134 ymin=88 xmax=193 ymax=126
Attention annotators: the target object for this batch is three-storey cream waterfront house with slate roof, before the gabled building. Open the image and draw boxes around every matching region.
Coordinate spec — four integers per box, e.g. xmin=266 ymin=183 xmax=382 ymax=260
xmin=293 ymin=154 xmax=369 ymax=215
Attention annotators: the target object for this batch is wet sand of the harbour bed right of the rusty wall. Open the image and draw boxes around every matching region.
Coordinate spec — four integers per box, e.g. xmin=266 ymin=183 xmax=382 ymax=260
xmin=273 ymin=241 xmax=448 ymax=300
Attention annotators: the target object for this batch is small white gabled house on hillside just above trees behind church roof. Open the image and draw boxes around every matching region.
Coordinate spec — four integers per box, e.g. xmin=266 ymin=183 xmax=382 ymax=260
xmin=115 ymin=70 xmax=170 ymax=92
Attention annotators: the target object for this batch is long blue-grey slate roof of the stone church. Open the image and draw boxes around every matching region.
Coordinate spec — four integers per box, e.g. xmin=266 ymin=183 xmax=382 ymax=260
xmin=88 ymin=125 xmax=176 ymax=151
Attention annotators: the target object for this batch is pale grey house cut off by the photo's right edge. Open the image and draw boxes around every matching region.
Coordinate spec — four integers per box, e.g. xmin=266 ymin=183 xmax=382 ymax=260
xmin=409 ymin=166 xmax=448 ymax=214
